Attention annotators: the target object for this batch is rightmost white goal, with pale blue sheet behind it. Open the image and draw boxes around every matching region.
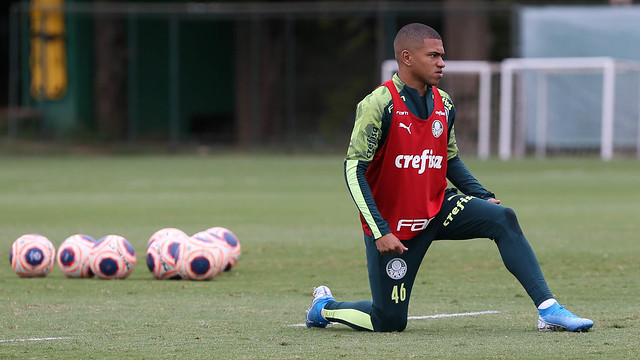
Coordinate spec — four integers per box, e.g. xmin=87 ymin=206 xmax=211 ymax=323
xmin=498 ymin=57 xmax=640 ymax=161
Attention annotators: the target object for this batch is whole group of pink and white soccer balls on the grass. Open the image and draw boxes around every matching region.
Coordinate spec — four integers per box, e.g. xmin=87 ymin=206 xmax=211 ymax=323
xmin=9 ymin=227 xmax=241 ymax=280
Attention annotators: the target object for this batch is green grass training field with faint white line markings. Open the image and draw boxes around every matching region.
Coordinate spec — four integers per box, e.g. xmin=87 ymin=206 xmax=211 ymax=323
xmin=0 ymin=154 xmax=640 ymax=359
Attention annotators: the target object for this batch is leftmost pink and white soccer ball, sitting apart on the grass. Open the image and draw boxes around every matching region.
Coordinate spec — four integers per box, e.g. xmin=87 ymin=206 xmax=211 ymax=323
xmin=9 ymin=234 xmax=56 ymax=277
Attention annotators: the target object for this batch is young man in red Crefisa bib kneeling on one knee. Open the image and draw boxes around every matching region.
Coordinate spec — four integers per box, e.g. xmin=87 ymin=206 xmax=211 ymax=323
xmin=306 ymin=24 xmax=593 ymax=331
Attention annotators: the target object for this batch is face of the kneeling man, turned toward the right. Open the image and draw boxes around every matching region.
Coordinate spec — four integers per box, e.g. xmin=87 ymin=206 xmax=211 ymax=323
xmin=410 ymin=39 xmax=445 ymax=86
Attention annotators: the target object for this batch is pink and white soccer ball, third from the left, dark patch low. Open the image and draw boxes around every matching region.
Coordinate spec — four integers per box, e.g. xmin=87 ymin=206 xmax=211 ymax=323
xmin=89 ymin=235 xmax=136 ymax=279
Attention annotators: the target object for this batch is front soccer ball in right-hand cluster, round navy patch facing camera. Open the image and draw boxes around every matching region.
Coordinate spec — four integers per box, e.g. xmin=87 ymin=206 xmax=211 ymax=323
xmin=179 ymin=237 xmax=224 ymax=280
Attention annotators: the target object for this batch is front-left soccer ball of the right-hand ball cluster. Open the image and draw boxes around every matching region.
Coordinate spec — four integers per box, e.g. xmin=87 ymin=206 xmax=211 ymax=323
xmin=147 ymin=230 xmax=189 ymax=279
